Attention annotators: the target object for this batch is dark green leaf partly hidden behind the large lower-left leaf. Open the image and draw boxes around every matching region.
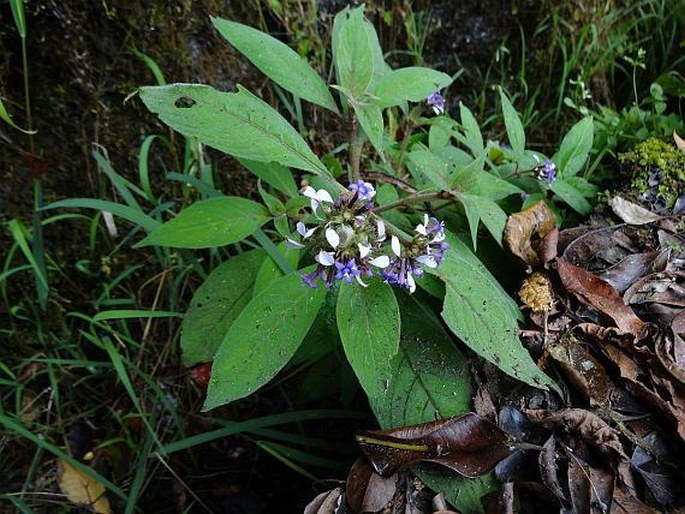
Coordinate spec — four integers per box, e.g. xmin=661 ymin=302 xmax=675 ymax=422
xmin=181 ymin=250 xmax=266 ymax=366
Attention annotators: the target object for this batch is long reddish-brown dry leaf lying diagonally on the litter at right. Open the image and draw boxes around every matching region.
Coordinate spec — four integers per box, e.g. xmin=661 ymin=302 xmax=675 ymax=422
xmin=555 ymin=258 xmax=644 ymax=338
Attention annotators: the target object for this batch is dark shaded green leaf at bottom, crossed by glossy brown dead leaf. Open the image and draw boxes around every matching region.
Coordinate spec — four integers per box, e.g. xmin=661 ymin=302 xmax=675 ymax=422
xmin=371 ymin=294 xmax=496 ymax=514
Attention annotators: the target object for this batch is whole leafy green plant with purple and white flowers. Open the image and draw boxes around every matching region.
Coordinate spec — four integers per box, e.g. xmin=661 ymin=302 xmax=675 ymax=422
xmin=131 ymin=8 xmax=594 ymax=508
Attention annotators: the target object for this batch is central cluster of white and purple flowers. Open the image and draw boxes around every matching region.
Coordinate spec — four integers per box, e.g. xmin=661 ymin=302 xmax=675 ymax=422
xmin=287 ymin=180 xmax=448 ymax=292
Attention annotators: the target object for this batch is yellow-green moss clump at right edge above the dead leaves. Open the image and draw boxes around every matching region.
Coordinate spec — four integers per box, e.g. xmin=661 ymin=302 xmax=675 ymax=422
xmin=618 ymin=138 xmax=685 ymax=211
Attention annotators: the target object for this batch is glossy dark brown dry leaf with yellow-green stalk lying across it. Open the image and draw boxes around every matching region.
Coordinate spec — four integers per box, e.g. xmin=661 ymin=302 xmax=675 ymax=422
xmin=356 ymin=412 xmax=510 ymax=478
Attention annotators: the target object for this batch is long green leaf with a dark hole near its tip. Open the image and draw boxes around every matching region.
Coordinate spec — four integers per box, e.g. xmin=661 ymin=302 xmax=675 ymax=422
xmin=139 ymin=84 xmax=329 ymax=176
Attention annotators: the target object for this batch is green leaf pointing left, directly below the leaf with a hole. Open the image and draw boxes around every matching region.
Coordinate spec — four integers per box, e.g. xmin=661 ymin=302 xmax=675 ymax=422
xmin=136 ymin=196 xmax=270 ymax=248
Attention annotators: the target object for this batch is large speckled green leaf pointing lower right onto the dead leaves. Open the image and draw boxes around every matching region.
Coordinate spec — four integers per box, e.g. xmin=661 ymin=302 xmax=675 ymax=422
xmin=428 ymin=230 xmax=560 ymax=392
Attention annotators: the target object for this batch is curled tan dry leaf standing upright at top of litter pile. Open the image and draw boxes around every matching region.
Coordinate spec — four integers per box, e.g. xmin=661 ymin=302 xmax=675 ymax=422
xmin=504 ymin=201 xmax=556 ymax=266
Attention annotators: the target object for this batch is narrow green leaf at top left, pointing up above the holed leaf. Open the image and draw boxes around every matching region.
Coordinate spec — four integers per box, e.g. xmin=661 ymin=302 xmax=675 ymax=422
xmin=212 ymin=17 xmax=338 ymax=113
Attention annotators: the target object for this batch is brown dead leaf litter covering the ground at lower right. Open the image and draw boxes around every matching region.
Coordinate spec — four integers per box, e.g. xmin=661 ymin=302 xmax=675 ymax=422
xmin=306 ymin=197 xmax=685 ymax=514
